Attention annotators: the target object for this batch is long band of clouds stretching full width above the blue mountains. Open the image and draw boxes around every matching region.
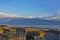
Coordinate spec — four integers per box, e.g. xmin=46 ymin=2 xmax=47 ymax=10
xmin=0 ymin=12 xmax=60 ymax=20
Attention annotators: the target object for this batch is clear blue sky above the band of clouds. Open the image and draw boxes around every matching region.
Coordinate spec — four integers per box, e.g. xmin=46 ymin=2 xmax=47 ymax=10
xmin=0 ymin=0 xmax=60 ymax=16
